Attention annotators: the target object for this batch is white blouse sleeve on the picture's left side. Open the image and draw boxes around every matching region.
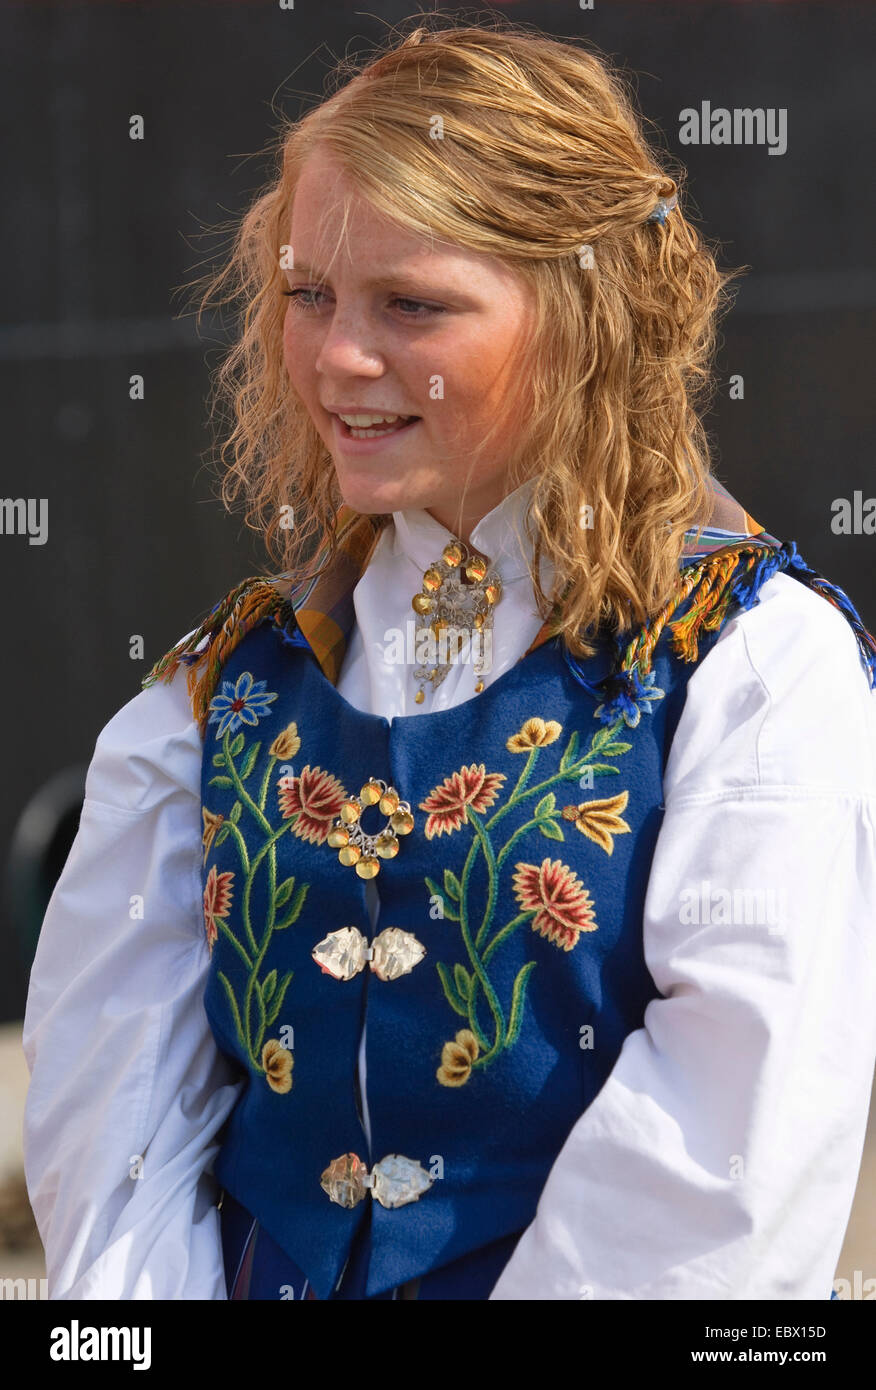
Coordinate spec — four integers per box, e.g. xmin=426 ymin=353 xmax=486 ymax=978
xmin=24 ymin=653 xmax=243 ymax=1300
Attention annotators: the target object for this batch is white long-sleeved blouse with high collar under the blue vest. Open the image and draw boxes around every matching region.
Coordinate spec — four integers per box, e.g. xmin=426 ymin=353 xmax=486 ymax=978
xmin=24 ymin=485 xmax=876 ymax=1300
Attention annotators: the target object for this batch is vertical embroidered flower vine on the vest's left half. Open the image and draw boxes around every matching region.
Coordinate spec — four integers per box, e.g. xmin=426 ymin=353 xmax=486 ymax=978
xmin=203 ymin=671 xmax=312 ymax=1095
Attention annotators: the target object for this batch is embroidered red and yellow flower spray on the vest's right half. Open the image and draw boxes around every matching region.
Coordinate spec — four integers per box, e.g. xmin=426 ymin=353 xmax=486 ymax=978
xmin=420 ymin=716 xmax=633 ymax=1087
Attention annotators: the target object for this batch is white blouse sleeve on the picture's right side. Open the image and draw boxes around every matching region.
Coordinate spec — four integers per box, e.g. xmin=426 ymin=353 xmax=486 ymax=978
xmin=491 ymin=573 xmax=876 ymax=1300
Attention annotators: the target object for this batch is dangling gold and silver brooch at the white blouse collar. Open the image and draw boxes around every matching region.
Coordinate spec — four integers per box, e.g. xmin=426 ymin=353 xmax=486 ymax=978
xmin=410 ymin=541 xmax=502 ymax=705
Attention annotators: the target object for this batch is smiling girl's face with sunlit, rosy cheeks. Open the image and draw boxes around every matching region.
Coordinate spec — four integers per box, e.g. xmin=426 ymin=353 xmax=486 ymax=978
xmin=284 ymin=152 xmax=531 ymax=541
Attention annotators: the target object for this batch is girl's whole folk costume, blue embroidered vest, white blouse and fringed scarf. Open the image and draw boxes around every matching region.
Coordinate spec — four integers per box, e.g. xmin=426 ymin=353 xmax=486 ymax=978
xmin=25 ymin=482 xmax=876 ymax=1300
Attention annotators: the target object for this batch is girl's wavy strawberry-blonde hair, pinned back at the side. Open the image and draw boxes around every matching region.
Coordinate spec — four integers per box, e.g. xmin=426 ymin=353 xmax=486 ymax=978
xmin=191 ymin=14 xmax=731 ymax=657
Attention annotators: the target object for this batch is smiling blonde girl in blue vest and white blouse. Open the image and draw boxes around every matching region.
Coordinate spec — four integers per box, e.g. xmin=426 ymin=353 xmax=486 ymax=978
xmin=24 ymin=22 xmax=876 ymax=1300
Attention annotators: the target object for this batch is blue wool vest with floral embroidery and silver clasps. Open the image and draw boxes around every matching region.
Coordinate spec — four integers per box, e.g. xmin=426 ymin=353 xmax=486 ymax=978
xmin=147 ymin=522 xmax=876 ymax=1298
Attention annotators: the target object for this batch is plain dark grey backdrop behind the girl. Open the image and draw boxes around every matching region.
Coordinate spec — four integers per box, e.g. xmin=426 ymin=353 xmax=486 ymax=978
xmin=0 ymin=0 xmax=876 ymax=1019
